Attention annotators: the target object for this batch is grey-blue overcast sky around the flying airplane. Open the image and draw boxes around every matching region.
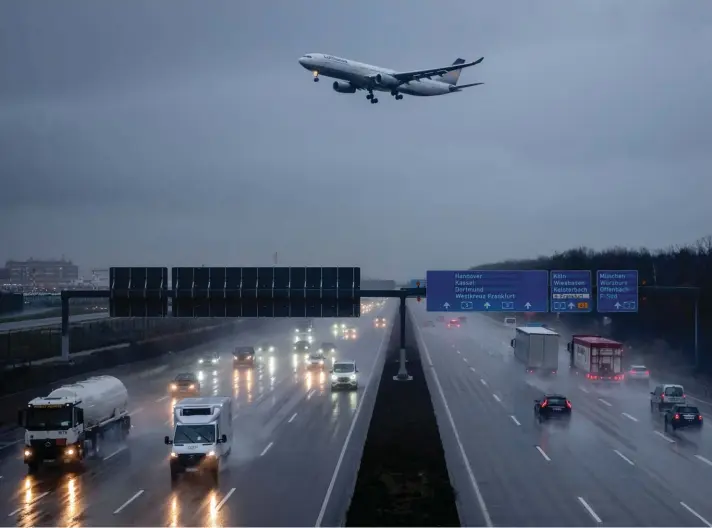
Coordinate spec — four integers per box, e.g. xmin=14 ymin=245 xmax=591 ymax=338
xmin=0 ymin=0 xmax=712 ymax=278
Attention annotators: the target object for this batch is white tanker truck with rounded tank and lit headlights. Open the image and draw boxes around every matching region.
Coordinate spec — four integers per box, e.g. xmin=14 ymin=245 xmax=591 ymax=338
xmin=18 ymin=376 xmax=131 ymax=473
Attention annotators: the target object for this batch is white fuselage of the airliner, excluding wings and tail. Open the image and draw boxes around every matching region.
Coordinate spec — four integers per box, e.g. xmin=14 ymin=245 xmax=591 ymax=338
xmin=299 ymin=53 xmax=457 ymax=97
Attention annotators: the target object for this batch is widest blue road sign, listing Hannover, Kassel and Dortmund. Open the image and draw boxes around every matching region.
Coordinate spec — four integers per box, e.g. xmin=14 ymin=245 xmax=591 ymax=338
xmin=426 ymin=270 xmax=549 ymax=312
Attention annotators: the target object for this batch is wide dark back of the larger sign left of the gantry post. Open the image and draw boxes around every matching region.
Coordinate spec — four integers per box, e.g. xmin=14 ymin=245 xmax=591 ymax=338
xmin=171 ymin=267 xmax=361 ymax=317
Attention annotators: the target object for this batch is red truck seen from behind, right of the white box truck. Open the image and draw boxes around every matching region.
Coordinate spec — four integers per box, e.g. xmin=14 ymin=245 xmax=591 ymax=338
xmin=566 ymin=335 xmax=625 ymax=383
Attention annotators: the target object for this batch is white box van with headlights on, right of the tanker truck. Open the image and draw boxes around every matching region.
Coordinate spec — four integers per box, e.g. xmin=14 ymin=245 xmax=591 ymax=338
xmin=164 ymin=397 xmax=232 ymax=485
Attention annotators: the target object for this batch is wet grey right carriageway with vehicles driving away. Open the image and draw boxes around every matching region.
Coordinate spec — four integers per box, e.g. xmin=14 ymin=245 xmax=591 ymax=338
xmin=409 ymin=301 xmax=712 ymax=526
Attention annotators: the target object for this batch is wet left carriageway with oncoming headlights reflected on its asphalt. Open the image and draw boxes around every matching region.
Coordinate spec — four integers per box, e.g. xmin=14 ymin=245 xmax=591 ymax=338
xmin=0 ymin=302 xmax=396 ymax=526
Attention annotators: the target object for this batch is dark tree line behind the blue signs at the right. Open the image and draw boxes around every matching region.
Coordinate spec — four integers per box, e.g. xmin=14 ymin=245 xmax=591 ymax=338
xmin=471 ymin=235 xmax=712 ymax=372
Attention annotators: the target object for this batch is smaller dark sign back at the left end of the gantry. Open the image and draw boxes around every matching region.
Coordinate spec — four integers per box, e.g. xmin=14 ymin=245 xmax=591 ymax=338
xmin=109 ymin=268 xmax=168 ymax=317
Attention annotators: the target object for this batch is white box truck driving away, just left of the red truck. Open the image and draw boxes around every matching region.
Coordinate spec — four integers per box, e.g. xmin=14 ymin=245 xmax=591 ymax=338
xmin=512 ymin=326 xmax=559 ymax=375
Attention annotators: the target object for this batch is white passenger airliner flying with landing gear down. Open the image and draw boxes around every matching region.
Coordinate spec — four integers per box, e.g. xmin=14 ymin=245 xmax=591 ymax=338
xmin=299 ymin=53 xmax=484 ymax=104
